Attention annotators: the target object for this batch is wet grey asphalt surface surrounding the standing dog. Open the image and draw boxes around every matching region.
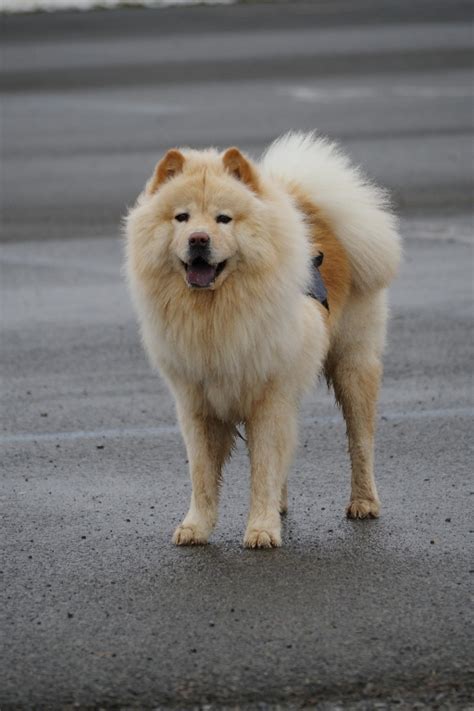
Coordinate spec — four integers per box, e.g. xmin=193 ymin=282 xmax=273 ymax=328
xmin=0 ymin=0 xmax=473 ymax=710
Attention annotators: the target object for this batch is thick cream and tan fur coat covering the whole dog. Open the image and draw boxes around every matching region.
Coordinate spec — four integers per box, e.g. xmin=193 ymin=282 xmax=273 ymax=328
xmin=126 ymin=134 xmax=400 ymax=547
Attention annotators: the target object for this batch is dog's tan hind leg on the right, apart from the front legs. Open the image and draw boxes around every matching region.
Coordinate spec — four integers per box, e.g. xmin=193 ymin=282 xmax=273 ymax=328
xmin=326 ymin=298 xmax=386 ymax=518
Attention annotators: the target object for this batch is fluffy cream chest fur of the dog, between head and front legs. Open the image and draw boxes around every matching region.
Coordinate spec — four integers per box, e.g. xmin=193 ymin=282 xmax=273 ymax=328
xmin=144 ymin=290 xmax=308 ymax=422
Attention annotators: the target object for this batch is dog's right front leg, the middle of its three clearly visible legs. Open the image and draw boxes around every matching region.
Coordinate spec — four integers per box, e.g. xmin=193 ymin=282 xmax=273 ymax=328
xmin=244 ymin=390 xmax=297 ymax=548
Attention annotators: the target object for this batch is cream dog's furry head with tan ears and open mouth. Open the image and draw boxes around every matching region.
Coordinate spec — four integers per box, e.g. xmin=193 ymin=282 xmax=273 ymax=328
xmin=129 ymin=148 xmax=278 ymax=290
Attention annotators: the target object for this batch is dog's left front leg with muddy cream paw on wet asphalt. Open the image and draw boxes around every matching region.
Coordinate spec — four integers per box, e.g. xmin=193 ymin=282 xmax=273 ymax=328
xmin=173 ymin=408 xmax=234 ymax=546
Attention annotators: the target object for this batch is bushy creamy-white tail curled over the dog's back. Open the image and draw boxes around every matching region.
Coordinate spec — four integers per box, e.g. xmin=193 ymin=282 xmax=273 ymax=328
xmin=261 ymin=133 xmax=401 ymax=292
